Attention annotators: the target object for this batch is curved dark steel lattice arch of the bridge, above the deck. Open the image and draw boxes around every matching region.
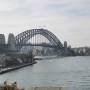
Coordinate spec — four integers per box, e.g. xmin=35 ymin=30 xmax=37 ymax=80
xmin=15 ymin=29 xmax=63 ymax=48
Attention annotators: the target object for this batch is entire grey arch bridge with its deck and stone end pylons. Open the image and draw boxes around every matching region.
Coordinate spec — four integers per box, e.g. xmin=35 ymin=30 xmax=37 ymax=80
xmin=0 ymin=28 xmax=73 ymax=56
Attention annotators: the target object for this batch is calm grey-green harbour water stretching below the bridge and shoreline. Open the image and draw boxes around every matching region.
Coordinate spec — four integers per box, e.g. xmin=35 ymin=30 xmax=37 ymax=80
xmin=0 ymin=56 xmax=90 ymax=90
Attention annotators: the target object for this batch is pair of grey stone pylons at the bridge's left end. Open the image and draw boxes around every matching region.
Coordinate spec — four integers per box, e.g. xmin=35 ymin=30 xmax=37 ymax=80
xmin=0 ymin=33 xmax=16 ymax=54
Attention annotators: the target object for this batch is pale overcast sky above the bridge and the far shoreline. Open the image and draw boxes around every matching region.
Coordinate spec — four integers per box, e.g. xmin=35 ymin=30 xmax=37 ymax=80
xmin=0 ymin=0 xmax=90 ymax=47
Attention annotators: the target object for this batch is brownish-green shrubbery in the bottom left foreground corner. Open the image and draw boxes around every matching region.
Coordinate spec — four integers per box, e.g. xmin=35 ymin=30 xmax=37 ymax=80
xmin=0 ymin=81 xmax=24 ymax=90
